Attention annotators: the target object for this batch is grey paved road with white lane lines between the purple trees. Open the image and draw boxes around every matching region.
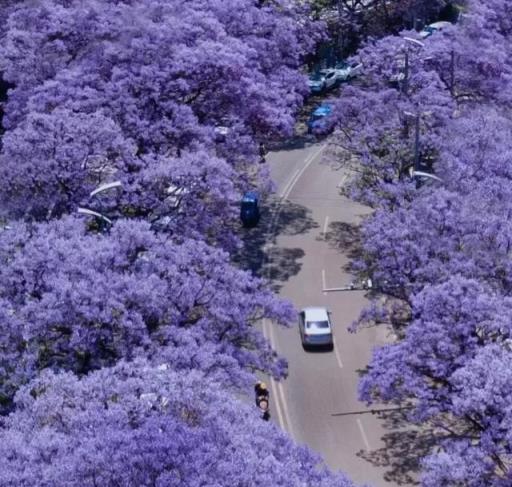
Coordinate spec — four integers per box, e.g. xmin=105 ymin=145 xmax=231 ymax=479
xmin=256 ymin=140 xmax=412 ymax=487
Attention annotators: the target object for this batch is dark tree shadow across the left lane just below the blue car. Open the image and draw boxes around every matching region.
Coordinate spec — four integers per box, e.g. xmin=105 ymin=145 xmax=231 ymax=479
xmin=233 ymin=200 xmax=318 ymax=291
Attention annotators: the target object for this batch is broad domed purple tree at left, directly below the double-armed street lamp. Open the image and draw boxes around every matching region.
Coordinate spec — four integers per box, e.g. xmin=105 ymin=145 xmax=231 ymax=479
xmin=0 ymin=218 xmax=292 ymax=408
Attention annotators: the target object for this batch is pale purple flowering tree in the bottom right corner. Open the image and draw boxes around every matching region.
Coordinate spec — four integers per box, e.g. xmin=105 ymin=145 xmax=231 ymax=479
xmin=423 ymin=344 xmax=512 ymax=487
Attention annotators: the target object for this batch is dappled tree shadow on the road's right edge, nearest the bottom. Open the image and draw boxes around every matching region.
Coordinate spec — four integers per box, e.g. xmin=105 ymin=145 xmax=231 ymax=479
xmin=357 ymin=410 xmax=439 ymax=486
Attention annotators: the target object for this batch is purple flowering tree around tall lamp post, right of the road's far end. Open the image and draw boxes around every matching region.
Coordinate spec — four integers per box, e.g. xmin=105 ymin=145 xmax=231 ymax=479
xmin=329 ymin=31 xmax=456 ymax=206
